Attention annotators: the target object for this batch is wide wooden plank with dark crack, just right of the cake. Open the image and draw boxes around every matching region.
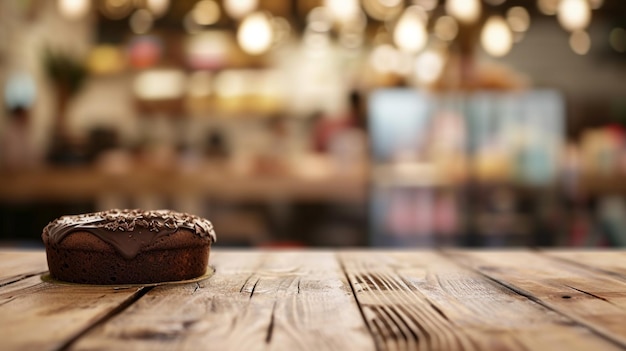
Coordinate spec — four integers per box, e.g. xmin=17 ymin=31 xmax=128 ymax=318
xmin=74 ymin=251 xmax=374 ymax=350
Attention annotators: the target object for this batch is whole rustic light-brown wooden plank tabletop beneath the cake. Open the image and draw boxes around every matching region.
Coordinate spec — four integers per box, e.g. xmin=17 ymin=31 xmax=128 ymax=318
xmin=0 ymin=250 xmax=626 ymax=351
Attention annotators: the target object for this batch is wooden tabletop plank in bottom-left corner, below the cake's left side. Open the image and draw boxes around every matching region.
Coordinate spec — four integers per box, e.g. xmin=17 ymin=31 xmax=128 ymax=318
xmin=0 ymin=272 xmax=140 ymax=350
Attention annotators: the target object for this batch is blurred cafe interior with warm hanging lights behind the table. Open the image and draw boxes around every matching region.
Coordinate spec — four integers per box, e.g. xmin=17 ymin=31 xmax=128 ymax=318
xmin=0 ymin=0 xmax=626 ymax=247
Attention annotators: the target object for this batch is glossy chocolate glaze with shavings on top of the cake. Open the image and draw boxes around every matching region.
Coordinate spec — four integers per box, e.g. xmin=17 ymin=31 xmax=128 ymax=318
xmin=43 ymin=209 xmax=216 ymax=259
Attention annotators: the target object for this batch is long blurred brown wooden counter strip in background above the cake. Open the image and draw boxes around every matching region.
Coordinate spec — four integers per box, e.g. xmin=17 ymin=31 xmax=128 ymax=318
xmin=0 ymin=163 xmax=367 ymax=202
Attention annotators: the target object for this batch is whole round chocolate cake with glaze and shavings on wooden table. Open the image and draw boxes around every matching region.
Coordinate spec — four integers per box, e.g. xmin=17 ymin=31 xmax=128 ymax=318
xmin=41 ymin=209 xmax=216 ymax=284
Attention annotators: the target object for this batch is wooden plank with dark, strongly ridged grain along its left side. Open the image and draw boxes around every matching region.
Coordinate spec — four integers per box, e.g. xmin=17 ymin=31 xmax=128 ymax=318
xmin=340 ymin=251 xmax=619 ymax=350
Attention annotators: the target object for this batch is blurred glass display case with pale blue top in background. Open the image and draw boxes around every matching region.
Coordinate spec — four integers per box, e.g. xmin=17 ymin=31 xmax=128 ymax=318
xmin=368 ymin=89 xmax=565 ymax=246
